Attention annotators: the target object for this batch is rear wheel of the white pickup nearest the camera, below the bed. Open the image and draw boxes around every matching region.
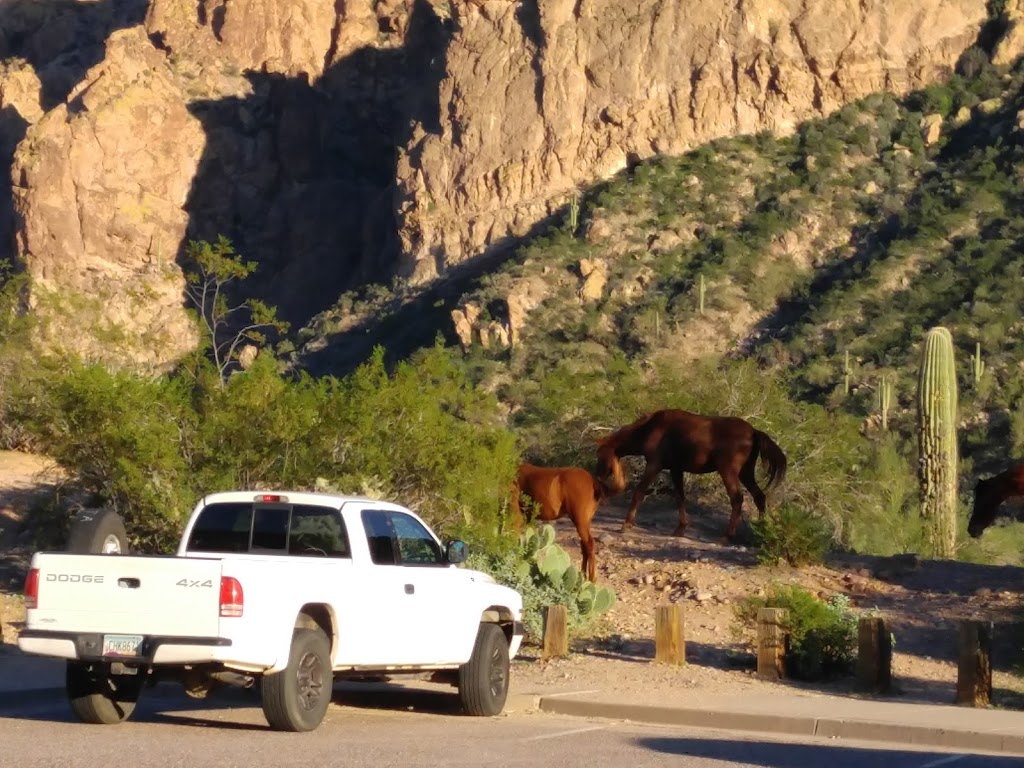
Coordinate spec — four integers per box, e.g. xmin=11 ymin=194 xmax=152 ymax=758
xmin=260 ymin=629 xmax=334 ymax=731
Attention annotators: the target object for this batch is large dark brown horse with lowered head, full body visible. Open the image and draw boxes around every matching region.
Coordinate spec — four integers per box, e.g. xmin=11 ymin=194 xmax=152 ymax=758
xmin=597 ymin=409 xmax=786 ymax=539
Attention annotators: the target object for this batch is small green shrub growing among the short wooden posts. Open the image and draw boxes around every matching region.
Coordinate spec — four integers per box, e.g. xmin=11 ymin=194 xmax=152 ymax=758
xmin=735 ymin=585 xmax=857 ymax=681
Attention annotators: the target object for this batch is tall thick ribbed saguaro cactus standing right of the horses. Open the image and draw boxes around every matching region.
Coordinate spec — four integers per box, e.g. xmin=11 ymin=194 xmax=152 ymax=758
xmin=918 ymin=327 xmax=958 ymax=557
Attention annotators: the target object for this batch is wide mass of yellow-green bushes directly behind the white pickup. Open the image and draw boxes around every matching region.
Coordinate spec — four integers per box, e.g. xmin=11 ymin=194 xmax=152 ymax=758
xmin=15 ymin=342 xmax=517 ymax=551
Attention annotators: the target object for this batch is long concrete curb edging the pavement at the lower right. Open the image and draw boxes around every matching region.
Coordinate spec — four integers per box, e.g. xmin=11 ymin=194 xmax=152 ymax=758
xmin=539 ymin=696 xmax=1024 ymax=755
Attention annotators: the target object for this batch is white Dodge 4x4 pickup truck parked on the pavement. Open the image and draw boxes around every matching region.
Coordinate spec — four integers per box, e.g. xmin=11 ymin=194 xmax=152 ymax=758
xmin=17 ymin=492 xmax=523 ymax=731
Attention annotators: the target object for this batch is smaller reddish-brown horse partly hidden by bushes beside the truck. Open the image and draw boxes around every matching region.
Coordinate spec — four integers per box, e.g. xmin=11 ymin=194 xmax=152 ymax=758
xmin=511 ymin=464 xmax=605 ymax=582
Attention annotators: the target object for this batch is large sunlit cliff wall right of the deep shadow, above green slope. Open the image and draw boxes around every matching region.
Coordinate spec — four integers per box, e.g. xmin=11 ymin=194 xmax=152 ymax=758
xmin=398 ymin=0 xmax=986 ymax=281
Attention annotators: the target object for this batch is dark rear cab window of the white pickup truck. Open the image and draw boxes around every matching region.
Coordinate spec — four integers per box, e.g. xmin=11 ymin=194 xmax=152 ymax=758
xmin=187 ymin=502 xmax=350 ymax=557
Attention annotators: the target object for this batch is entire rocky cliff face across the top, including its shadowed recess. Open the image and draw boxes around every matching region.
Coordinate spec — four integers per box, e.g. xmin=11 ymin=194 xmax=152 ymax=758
xmin=0 ymin=0 xmax=995 ymax=366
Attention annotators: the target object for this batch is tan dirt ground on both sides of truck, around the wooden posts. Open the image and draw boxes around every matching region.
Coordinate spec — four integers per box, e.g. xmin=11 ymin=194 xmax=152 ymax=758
xmin=0 ymin=452 xmax=1024 ymax=709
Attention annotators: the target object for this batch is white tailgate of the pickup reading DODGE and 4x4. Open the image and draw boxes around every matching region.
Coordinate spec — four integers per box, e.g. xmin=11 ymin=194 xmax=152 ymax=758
xmin=29 ymin=553 xmax=221 ymax=637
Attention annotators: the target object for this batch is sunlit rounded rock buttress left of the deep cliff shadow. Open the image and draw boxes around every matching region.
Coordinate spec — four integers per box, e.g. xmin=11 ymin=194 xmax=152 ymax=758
xmin=12 ymin=27 xmax=205 ymax=366
